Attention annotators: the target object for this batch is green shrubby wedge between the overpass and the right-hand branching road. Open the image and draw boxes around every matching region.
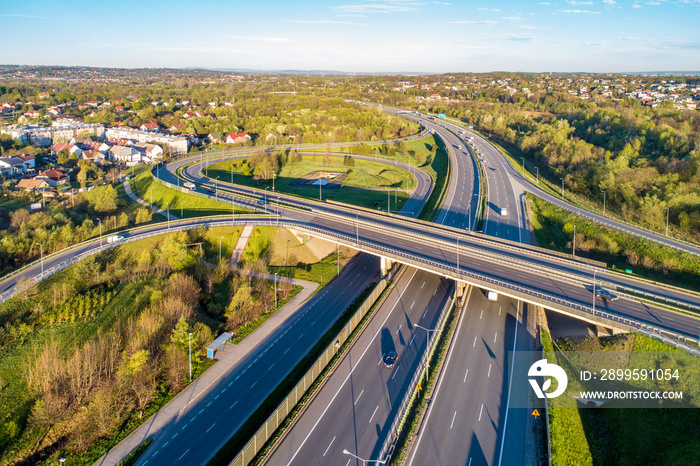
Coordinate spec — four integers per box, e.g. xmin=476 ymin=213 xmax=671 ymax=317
xmin=528 ymin=194 xmax=700 ymax=291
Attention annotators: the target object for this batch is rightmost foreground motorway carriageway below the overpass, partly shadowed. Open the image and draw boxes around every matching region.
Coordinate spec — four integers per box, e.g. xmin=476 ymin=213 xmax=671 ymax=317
xmin=407 ymin=287 xmax=523 ymax=466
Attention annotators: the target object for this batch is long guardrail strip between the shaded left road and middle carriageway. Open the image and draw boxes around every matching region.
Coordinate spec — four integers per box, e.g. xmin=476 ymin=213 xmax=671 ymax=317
xmin=229 ymin=280 xmax=387 ymax=466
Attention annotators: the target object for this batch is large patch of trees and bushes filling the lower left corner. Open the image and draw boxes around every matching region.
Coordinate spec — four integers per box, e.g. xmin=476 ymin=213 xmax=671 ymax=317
xmin=0 ymin=227 xmax=314 ymax=464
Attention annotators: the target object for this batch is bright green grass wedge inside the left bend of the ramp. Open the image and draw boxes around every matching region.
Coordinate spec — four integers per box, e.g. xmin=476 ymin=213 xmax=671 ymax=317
xmin=130 ymin=166 xmax=247 ymax=218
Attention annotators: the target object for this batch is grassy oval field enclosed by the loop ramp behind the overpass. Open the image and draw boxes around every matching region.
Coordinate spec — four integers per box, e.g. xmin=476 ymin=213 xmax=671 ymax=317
xmin=209 ymin=154 xmax=416 ymax=211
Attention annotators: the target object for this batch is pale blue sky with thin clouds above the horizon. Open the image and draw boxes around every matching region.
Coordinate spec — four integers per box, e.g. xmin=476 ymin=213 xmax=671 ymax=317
xmin=0 ymin=0 xmax=700 ymax=73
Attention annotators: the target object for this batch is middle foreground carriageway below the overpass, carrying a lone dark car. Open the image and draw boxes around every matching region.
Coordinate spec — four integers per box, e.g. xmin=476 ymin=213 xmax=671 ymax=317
xmin=266 ymin=269 xmax=453 ymax=465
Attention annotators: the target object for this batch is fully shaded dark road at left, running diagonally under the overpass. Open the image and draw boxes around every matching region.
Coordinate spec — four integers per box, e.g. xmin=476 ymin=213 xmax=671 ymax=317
xmin=137 ymin=254 xmax=378 ymax=465
